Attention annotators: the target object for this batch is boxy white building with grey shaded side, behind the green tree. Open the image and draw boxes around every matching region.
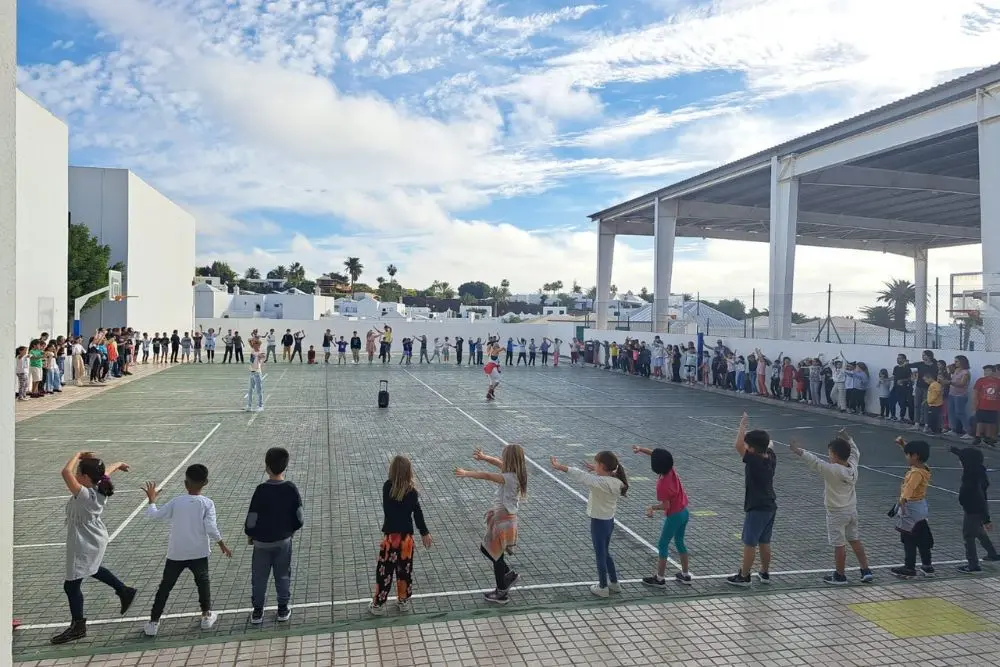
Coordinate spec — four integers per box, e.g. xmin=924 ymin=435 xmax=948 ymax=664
xmin=69 ymin=167 xmax=195 ymax=332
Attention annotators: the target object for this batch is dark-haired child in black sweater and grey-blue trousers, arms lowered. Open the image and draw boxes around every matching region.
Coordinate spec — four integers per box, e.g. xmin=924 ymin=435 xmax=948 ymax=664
xmin=244 ymin=447 xmax=303 ymax=625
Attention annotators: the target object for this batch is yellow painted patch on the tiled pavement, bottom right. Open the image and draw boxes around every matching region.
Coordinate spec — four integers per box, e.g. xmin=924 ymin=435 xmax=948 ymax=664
xmin=847 ymin=598 xmax=1000 ymax=639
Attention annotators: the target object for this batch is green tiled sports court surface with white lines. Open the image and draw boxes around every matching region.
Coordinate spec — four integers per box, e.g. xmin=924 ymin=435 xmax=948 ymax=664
xmin=14 ymin=363 xmax=998 ymax=659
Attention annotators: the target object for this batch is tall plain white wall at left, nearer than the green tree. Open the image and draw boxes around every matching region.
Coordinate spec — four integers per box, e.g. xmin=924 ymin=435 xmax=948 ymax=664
xmin=15 ymin=91 xmax=69 ymax=345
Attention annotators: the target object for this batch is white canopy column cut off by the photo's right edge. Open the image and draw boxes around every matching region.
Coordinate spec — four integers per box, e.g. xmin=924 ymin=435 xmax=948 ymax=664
xmin=979 ymin=86 xmax=1000 ymax=352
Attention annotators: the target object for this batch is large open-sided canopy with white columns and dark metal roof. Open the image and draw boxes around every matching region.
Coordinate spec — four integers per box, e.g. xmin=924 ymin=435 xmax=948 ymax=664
xmin=590 ymin=64 xmax=1000 ymax=350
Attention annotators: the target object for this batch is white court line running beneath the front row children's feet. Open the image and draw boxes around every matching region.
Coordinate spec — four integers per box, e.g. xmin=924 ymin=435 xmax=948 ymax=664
xmin=13 ymin=560 xmax=965 ymax=631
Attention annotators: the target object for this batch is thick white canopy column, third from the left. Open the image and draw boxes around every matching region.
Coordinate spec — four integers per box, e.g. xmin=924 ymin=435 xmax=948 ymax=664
xmin=768 ymin=157 xmax=799 ymax=340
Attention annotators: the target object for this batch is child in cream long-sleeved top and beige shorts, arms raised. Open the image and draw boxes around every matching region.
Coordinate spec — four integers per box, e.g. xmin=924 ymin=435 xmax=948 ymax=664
xmin=789 ymin=429 xmax=875 ymax=586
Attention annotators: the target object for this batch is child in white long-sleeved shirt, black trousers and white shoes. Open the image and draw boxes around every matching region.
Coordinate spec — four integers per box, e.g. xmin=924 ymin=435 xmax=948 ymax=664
xmin=143 ymin=463 xmax=233 ymax=637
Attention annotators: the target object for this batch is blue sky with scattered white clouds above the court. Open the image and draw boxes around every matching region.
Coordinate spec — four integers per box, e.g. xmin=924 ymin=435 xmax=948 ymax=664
xmin=18 ymin=0 xmax=1000 ymax=314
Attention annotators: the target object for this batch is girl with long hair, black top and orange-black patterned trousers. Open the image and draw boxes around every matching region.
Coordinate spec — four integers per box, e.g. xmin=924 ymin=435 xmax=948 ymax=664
xmin=368 ymin=456 xmax=432 ymax=616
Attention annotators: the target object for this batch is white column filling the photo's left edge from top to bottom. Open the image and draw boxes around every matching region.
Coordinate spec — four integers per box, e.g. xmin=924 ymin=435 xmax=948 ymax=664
xmin=0 ymin=0 xmax=17 ymax=665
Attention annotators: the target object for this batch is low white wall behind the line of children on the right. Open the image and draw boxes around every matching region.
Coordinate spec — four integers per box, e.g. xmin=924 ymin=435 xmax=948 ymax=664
xmin=584 ymin=329 xmax=1000 ymax=414
